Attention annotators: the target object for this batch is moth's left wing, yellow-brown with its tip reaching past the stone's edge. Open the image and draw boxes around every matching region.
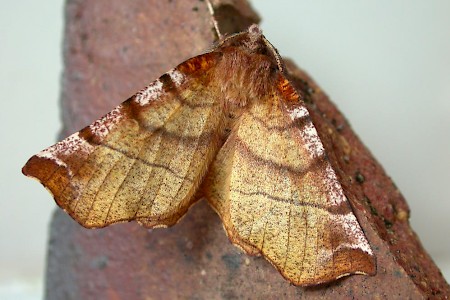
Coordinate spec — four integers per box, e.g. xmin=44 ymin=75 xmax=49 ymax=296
xmin=23 ymin=53 xmax=223 ymax=227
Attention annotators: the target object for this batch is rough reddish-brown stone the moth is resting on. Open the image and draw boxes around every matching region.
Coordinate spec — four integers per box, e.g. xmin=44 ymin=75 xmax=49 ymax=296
xmin=46 ymin=0 xmax=450 ymax=299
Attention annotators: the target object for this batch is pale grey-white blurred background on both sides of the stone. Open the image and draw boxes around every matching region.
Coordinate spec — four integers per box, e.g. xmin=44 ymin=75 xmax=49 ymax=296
xmin=0 ymin=0 xmax=450 ymax=299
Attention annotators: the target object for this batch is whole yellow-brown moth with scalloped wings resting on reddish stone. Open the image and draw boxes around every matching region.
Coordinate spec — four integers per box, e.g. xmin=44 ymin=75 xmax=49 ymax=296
xmin=23 ymin=25 xmax=376 ymax=286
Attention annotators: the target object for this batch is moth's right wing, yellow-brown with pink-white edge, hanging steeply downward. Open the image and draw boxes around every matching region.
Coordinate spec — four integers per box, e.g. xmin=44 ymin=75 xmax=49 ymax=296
xmin=204 ymin=77 xmax=376 ymax=285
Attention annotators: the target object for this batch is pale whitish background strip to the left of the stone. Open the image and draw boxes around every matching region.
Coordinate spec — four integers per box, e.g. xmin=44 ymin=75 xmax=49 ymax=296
xmin=0 ymin=0 xmax=63 ymax=299
